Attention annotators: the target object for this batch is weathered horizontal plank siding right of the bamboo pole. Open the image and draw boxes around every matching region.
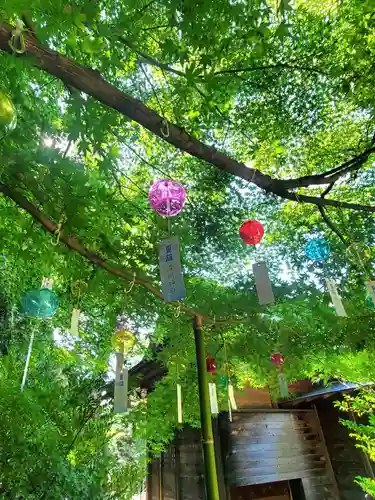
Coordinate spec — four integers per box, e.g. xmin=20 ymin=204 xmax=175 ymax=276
xmin=223 ymin=409 xmax=338 ymax=500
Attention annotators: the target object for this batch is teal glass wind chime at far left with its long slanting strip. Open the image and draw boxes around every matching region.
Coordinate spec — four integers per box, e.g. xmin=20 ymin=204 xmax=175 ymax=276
xmin=21 ymin=279 xmax=59 ymax=392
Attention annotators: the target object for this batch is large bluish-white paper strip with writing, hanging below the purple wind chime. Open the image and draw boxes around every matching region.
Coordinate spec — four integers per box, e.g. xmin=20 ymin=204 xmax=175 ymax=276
xmin=159 ymin=236 xmax=186 ymax=302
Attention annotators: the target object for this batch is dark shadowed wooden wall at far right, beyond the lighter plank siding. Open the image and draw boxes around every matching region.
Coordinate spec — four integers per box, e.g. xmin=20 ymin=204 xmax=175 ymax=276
xmin=317 ymin=400 xmax=369 ymax=500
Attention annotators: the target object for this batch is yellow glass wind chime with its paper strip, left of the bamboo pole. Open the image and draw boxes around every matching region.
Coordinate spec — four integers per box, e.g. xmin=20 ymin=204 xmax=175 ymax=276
xmin=112 ymin=326 xmax=136 ymax=413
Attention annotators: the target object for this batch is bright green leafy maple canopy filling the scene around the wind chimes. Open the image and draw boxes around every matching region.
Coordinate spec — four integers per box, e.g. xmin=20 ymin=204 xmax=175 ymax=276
xmin=0 ymin=0 xmax=375 ymax=498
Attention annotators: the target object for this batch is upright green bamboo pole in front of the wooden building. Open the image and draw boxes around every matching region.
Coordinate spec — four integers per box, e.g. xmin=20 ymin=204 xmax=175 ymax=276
xmin=194 ymin=316 xmax=220 ymax=500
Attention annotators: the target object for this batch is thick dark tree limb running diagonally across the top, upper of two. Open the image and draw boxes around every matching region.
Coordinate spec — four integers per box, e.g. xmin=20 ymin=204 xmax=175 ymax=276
xmin=0 ymin=23 xmax=375 ymax=212
